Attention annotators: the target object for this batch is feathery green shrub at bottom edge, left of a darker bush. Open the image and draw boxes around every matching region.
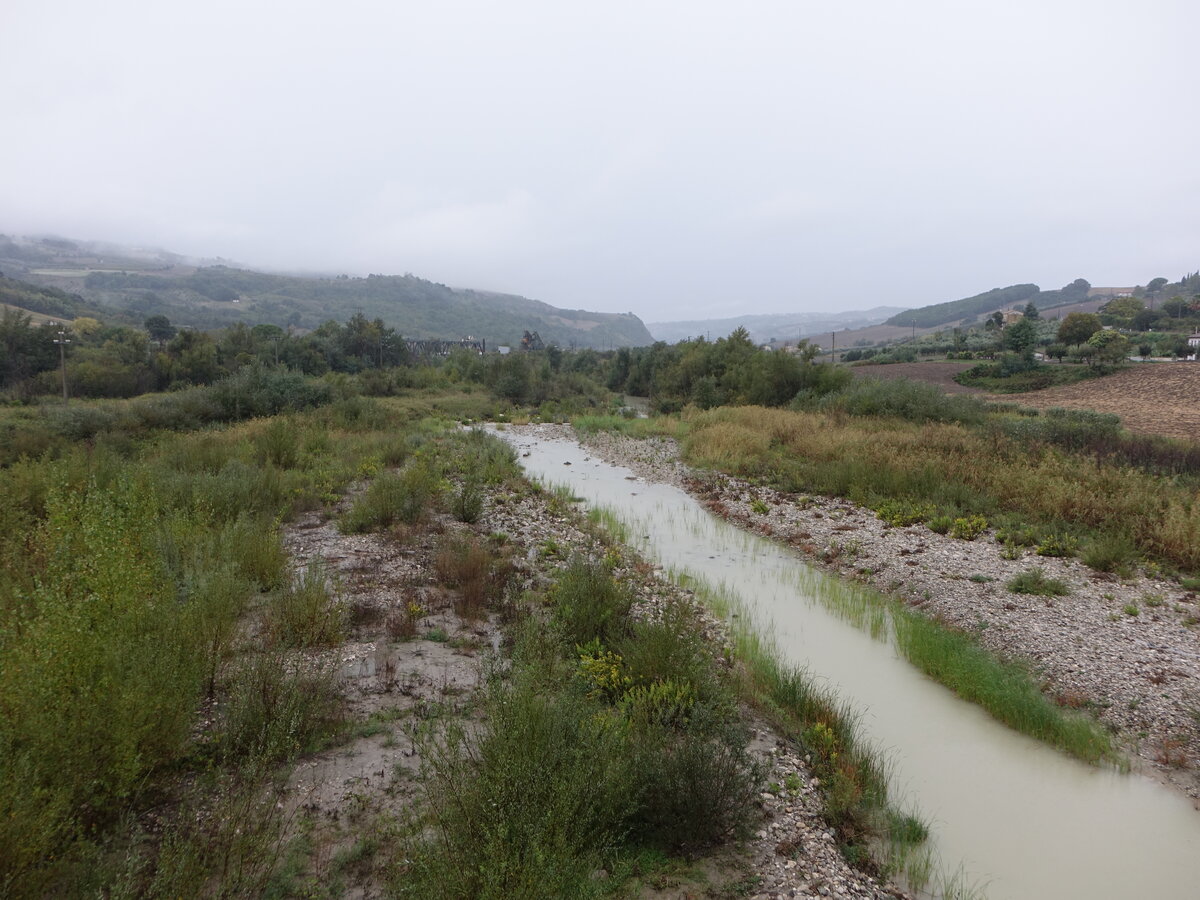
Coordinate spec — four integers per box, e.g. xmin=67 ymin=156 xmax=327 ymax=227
xmin=392 ymin=671 xmax=637 ymax=900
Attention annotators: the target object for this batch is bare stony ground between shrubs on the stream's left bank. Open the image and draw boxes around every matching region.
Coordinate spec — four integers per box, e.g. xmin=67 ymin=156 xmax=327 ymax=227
xmin=274 ymin=434 xmax=902 ymax=900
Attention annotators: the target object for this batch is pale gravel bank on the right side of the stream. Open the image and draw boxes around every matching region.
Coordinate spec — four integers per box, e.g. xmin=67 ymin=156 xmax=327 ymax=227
xmin=556 ymin=426 xmax=1200 ymax=802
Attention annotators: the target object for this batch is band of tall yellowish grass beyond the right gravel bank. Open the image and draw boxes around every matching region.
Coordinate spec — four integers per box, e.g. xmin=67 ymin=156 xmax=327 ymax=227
xmin=683 ymin=407 xmax=1200 ymax=571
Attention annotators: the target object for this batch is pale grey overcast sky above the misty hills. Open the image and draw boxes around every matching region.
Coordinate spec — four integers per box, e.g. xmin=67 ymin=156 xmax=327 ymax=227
xmin=0 ymin=0 xmax=1200 ymax=322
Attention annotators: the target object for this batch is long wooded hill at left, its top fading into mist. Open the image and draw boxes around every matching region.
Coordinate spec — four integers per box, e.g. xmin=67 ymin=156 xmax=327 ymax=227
xmin=0 ymin=235 xmax=654 ymax=348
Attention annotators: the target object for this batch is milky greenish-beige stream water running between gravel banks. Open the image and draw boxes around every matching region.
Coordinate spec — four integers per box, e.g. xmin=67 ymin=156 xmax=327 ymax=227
xmin=499 ymin=432 xmax=1200 ymax=900
